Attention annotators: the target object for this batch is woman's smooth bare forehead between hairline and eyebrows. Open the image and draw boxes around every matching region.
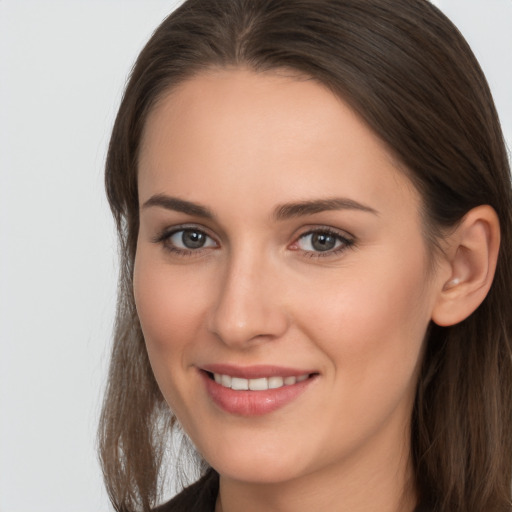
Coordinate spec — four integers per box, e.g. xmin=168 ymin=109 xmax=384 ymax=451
xmin=139 ymin=69 xmax=417 ymax=218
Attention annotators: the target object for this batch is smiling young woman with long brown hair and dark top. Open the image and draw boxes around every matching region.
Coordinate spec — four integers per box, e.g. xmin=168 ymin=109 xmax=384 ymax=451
xmin=100 ymin=0 xmax=512 ymax=512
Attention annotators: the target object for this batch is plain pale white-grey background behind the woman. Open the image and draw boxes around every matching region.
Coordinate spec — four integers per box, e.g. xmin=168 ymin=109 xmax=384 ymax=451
xmin=0 ymin=0 xmax=512 ymax=512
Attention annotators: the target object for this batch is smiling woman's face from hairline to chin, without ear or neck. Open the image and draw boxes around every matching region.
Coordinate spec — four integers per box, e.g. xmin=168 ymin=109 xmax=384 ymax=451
xmin=134 ymin=70 xmax=439 ymax=482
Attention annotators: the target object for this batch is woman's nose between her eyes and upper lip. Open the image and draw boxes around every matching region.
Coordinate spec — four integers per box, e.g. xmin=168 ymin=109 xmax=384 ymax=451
xmin=208 ymin=252 xmax=288 ymax=350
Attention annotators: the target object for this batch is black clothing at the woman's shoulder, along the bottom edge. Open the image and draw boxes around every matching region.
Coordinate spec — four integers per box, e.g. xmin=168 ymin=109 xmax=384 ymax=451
xmin=154 ymin=469 xmax=430 ymax=512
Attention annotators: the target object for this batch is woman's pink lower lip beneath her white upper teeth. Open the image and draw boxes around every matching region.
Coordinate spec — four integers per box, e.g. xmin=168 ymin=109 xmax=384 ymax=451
xmin=200 ymin=371 xmax=316 ymax=416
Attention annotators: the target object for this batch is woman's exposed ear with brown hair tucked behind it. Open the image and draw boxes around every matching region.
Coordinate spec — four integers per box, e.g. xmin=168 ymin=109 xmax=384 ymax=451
xmin=432 ymin=205 xmax=500 ymax=326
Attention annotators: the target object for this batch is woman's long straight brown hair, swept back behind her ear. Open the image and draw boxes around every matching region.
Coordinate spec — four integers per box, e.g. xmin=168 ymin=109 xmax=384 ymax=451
xmin=99 ymin=0 xmax=512 ymax=512
